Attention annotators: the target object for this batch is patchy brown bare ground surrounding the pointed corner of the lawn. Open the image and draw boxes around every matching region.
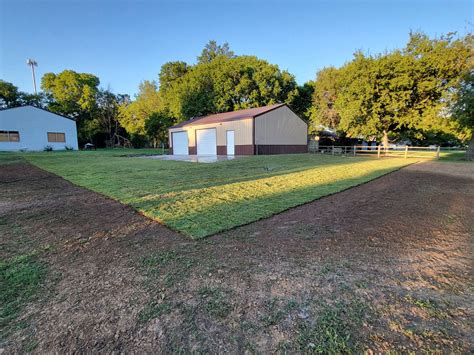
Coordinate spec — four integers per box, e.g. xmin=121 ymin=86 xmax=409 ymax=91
xmin=0 ymin=162 xmax=474 ymax=353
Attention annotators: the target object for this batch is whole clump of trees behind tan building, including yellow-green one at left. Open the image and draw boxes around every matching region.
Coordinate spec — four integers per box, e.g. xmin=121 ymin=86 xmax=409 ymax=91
xmin=119 ymin=41 xmax=304 ymax=144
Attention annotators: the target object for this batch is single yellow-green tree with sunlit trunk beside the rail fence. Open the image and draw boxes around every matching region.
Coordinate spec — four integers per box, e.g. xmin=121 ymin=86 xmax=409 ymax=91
xmin=334 ymin=51 xmax=412 ymax=146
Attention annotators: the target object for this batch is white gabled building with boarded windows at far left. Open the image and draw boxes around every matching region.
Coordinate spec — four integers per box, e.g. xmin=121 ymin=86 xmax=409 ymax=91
xmin=0 ymin=105 xmax=78 ymax=151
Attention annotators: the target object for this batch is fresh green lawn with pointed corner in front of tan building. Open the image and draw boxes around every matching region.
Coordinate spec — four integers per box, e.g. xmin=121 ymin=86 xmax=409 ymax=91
xmin=0 ymin=150 xmax=413 ymax=238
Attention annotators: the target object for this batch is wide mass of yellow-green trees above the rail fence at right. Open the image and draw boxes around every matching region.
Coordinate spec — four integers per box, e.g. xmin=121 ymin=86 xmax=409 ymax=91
xmin=312 ymin=33 xmax=472 ymax=145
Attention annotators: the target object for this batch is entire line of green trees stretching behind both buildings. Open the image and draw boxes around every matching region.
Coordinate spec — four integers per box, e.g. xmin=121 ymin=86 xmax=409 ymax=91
xmin=0 ymin=32 xmax=474 ymax=149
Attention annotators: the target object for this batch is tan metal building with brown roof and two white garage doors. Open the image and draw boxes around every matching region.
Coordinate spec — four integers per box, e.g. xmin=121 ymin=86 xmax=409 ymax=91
xmin=169 ymin=104 xmax=308 ymax=155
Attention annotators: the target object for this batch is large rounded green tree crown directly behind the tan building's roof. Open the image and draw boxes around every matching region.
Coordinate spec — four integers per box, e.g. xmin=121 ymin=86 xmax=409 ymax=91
xmin=163 ymin=56 xmax=298 ymax=121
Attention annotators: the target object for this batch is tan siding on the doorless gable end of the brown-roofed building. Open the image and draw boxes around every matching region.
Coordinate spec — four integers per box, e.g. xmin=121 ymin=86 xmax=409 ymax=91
xmin=255 ymin=106 xmax=308 ymax=145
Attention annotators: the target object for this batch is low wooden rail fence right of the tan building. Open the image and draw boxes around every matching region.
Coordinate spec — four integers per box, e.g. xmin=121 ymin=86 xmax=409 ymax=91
xmin=308 ymin=145 xmax=463 ymax=159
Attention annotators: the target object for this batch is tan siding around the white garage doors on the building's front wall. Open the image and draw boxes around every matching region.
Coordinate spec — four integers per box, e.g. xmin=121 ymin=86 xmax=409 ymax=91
xmin=169 ymin=118 xmax=253 ymax=147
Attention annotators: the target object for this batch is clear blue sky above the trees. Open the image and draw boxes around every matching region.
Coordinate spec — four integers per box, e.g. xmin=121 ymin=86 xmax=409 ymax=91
xmin=0 ymin=0 xmax=474 ymax=95
